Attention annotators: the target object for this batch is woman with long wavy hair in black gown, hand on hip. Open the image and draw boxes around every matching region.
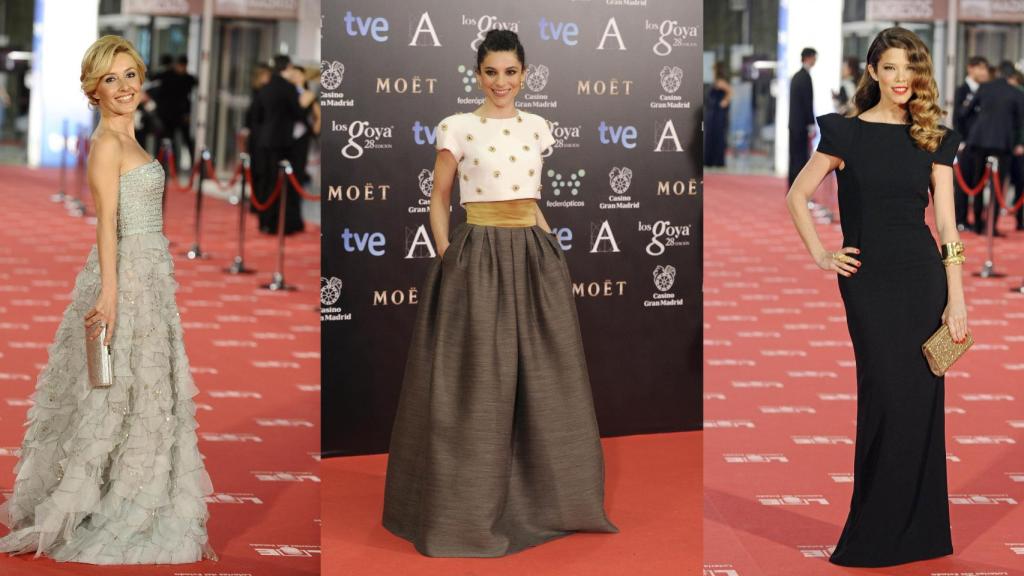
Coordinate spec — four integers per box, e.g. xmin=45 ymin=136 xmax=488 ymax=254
xmin=787 ymin=28 xmax=968 ymax=567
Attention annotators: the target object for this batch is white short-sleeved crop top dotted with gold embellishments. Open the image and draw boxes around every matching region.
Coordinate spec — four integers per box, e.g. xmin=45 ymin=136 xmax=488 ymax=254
xmin=435 ymin=111 xmax=555 ymax=205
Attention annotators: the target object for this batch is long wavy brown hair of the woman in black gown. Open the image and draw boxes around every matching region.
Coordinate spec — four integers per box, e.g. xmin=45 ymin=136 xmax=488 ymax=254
xmin=849 ymin=27 xmax=945 ymax=152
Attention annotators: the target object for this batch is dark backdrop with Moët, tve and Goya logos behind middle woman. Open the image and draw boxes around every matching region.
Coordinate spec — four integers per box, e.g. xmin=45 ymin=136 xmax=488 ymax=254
xmin=321 ymin=0 xmax=703 ymax=455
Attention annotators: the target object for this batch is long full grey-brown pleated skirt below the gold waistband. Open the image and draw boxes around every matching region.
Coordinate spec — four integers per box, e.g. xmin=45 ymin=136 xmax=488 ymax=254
xmin=384 ymin=223 xmax=617 ymax=557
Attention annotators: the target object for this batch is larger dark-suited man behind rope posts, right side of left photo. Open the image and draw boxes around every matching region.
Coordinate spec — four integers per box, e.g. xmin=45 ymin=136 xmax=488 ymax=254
xmin=252 ymin=54 xmax=304 ymax=234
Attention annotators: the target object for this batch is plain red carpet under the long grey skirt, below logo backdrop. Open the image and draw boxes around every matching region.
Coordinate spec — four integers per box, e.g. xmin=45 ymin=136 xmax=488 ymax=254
xmin=323 ymin=431 xmax=701 ymax=576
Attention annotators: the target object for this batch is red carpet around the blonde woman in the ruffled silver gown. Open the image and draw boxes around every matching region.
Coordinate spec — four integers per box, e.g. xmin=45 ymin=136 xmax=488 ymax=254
xmin=0 ymin=163 xmax=319 ymax=576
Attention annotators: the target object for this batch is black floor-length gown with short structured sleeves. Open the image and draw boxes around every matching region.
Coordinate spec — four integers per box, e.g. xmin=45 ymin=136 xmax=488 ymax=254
xmin=818 ymin=114 xmax=961 ymax=567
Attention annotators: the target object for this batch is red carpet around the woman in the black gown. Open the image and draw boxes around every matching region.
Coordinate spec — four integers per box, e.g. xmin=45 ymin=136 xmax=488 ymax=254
xmin=705 ymin=175 xmax=1024 ymax=576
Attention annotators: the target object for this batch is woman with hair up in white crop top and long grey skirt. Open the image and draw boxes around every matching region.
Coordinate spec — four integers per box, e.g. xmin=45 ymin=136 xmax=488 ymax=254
xmin=384 ymin=31 xmax=616 ymax=557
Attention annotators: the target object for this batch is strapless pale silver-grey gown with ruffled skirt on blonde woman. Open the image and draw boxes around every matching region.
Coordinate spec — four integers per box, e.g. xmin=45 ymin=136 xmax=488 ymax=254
xmin=0 ymin=161 xmax=215 ymax=564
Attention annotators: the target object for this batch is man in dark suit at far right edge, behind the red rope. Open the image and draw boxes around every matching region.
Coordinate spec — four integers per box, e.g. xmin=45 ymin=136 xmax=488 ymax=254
xmin=967 ymin=61 xmax=1024 ymax=236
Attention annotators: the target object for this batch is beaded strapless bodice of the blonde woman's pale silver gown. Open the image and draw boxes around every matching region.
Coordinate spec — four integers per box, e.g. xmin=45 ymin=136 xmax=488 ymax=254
xmin=118 ymin=160 xmax=164 ymax=238
